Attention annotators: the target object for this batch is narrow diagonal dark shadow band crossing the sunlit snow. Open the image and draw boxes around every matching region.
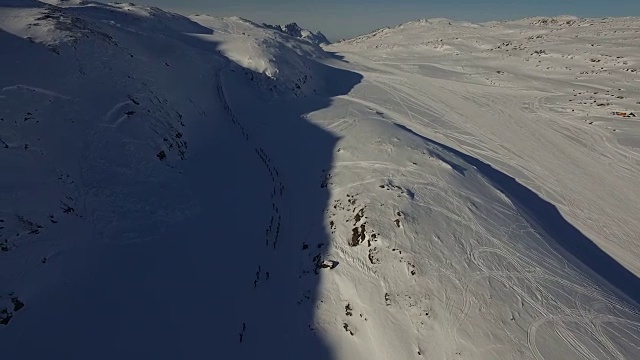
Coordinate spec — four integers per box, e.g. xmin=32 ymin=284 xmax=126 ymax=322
xmin=395 ymin=124 xmax=640 ymax=306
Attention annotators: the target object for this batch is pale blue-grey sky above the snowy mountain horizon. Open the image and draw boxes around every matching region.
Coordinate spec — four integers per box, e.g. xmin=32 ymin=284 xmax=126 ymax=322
xmin=133 ymin=0 xmax=640 ymax=40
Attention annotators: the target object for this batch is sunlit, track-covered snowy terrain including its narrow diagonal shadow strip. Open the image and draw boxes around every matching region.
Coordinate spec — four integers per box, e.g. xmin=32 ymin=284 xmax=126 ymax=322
xmin=318 ymin=18 xmax=640 ymax=359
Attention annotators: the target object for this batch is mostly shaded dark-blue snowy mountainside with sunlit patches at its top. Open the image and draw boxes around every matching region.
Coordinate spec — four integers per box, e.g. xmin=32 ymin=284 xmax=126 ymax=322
xmin=0 ymin=0 xmax=357 ymax=359
